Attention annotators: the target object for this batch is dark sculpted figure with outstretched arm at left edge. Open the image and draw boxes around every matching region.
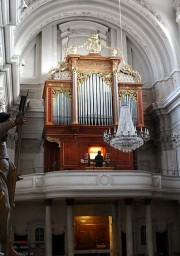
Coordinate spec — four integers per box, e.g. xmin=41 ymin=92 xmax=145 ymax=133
xmin=0 ymin=112 xmax=26 ymax=256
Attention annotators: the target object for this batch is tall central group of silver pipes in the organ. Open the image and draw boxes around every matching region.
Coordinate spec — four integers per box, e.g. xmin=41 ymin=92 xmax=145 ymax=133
xmin=78 ymin=74 xmax=113 ymax=125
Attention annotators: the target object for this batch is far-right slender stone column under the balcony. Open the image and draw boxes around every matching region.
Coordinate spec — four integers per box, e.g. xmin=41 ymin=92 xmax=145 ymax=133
xmin=144 ymin=199 xmax=154 ymax=256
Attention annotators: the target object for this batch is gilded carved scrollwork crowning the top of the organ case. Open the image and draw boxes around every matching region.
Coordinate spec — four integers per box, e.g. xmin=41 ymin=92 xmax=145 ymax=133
xmin=48 ymin=33 xmax=142 ymax=84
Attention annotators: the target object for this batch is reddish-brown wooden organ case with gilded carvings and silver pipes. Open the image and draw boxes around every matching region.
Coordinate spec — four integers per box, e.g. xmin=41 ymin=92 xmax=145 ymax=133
xmin=43 ymin=33 xmax=144 ymax=171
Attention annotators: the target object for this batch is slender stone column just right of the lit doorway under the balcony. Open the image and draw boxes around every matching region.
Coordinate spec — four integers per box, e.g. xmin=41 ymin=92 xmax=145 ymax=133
xmin=125 ymin=199 xmax=133 ymax=256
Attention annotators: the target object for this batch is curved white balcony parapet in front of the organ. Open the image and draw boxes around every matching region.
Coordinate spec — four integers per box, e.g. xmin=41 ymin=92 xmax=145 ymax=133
xmin=15 ymin=170 xmax=180 ymax=201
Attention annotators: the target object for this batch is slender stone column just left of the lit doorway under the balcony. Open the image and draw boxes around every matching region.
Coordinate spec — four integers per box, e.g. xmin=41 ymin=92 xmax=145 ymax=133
xmin=66 ymin=199 xmax=74 ymax=256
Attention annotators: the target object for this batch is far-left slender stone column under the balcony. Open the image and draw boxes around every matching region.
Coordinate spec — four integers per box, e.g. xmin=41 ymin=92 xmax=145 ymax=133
xmin=45 ymin=199 xmax=52 ymax=256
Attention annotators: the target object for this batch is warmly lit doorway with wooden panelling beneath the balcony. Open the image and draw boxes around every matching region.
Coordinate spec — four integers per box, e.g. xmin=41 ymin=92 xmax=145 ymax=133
xmin=74 ymin=216 xmax=112 ymax=256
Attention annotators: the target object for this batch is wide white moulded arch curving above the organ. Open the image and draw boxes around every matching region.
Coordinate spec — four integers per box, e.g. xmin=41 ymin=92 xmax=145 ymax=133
xmin=15 ymin=0 xmax=179 ymax=84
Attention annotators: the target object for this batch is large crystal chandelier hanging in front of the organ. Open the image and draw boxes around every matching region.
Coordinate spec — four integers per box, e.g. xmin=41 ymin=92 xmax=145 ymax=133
xmin=104 ymin=104 xmax=150 ymax=152
